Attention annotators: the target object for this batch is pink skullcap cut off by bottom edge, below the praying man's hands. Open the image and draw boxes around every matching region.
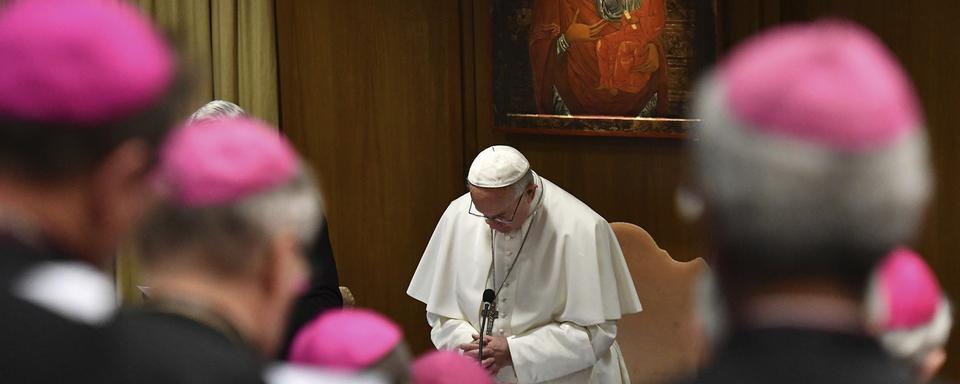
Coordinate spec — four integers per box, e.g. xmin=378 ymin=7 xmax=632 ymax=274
xmin=411 ymin=351 xmax=493 ymax=384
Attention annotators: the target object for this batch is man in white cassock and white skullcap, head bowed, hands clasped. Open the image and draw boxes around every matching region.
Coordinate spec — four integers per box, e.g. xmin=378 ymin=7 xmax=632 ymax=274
xmin=407 ymin=146 xmax=641 ymax=383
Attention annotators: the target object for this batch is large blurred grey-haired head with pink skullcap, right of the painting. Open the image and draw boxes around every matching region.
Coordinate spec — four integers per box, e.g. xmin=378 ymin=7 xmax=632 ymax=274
xmin=692 ymin=21 xmax=932 ymax=314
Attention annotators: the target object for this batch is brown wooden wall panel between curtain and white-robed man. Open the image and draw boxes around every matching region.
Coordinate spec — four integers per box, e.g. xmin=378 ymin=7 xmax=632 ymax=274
xmin=277 ymin=0 xmax=463 ymax=351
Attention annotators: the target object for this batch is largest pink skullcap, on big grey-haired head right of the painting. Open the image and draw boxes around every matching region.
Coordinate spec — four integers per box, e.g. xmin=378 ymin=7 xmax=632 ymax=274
xmin=718 ymin=21 xmax=922 ymax=151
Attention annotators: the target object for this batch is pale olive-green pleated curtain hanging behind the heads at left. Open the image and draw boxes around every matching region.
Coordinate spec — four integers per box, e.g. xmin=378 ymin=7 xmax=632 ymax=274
xmin=115 ymin=0 xmax=280 ymax=304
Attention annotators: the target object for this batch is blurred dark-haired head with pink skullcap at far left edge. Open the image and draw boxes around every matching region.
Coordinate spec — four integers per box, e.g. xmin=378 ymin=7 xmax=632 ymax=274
xmin=0 ymin=0 xmax=183 ymax=265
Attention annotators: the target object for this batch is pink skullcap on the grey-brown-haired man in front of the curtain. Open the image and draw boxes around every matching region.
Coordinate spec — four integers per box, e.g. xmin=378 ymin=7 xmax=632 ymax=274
xmin=157 ymin=119 xmax=299 ymax=207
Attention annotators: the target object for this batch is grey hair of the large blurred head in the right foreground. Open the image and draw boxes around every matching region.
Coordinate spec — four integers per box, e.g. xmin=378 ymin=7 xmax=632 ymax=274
xmin=693 ymin=74 xmax=932 ymax=279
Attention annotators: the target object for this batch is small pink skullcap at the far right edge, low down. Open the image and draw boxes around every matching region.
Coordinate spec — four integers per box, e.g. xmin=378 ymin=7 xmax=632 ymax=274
xmin=873 ymin=248 xmax=942 ymax=330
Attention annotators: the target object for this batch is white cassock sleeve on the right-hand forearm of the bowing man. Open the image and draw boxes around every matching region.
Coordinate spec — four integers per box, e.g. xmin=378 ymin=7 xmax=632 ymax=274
xmin=507 ymin=321 xmax=617 ymax=383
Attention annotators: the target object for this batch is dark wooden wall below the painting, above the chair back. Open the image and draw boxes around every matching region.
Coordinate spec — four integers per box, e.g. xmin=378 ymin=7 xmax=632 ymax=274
xmin=479 ymin=134 xmax=705 ymax=264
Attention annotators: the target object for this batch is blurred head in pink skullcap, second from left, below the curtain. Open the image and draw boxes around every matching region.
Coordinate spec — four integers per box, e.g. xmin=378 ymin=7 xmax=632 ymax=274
xmin=139 ymin=118 xmax=322 ymax=356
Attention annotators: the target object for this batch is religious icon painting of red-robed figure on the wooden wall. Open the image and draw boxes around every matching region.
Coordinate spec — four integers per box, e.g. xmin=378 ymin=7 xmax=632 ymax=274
xmin=490 ymin=0 xmax=717 ymax=138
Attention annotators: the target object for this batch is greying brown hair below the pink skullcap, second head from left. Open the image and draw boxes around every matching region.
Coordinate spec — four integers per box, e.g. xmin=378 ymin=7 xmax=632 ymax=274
xmin=139 ymin=165 xmax=323 ymax=275
